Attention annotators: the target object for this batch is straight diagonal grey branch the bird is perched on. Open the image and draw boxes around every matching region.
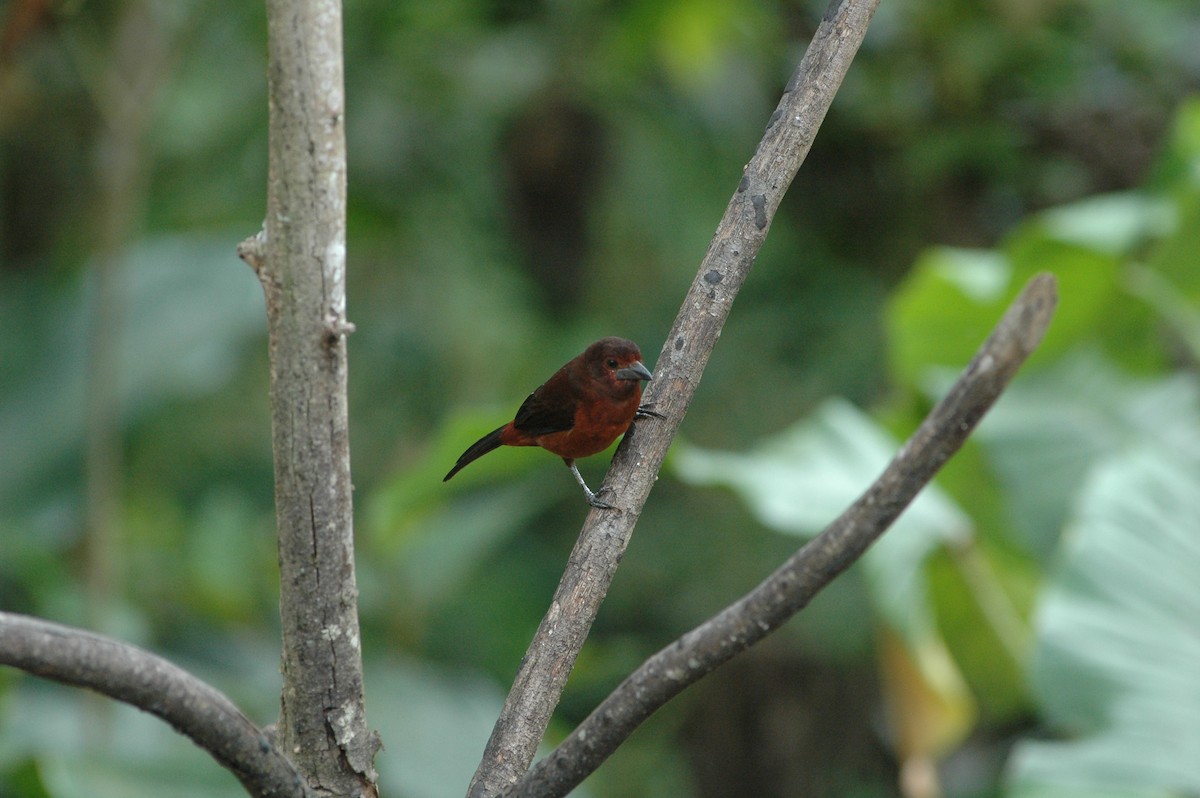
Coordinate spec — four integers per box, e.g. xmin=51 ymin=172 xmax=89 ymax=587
xmin=468 ymin=0 xmax=880 ymax=798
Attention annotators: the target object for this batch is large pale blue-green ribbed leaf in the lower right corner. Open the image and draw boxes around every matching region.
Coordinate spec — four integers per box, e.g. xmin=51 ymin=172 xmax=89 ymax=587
xmin=1008 ymin=446 xmax=1200 ymax=798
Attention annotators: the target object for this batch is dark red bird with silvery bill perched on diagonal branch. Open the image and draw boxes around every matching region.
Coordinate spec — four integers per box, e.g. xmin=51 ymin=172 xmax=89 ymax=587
xmin=442 ymin=338 xmax=659 ymax=510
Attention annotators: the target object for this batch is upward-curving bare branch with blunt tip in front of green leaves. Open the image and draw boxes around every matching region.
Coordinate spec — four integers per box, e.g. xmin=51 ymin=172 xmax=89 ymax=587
xmin=508 ymin=274 xmax=1057 ymax=798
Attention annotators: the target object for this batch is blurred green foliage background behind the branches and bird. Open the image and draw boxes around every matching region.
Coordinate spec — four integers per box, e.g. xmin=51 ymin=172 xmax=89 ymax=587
xmin=0 ymin=0 xmax=1200 ymax=798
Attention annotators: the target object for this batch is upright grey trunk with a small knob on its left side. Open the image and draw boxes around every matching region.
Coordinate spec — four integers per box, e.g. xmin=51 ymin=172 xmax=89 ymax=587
xmin=260 ymin=0 xmax=379 ymax=796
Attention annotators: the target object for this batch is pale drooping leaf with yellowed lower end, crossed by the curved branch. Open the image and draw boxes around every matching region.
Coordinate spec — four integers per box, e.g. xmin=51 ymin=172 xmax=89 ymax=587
xmin=673 ymin=400 xmax=974 ymax=757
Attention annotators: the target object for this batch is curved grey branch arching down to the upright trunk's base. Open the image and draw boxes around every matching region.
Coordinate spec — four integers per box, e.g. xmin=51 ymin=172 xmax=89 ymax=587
xmin=0 ymin=612 xmax=311 ymax=798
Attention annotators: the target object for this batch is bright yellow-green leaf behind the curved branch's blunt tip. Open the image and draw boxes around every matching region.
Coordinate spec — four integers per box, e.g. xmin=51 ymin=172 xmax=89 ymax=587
xmin=887 ymin=176 xmax=1200 ymax=388
